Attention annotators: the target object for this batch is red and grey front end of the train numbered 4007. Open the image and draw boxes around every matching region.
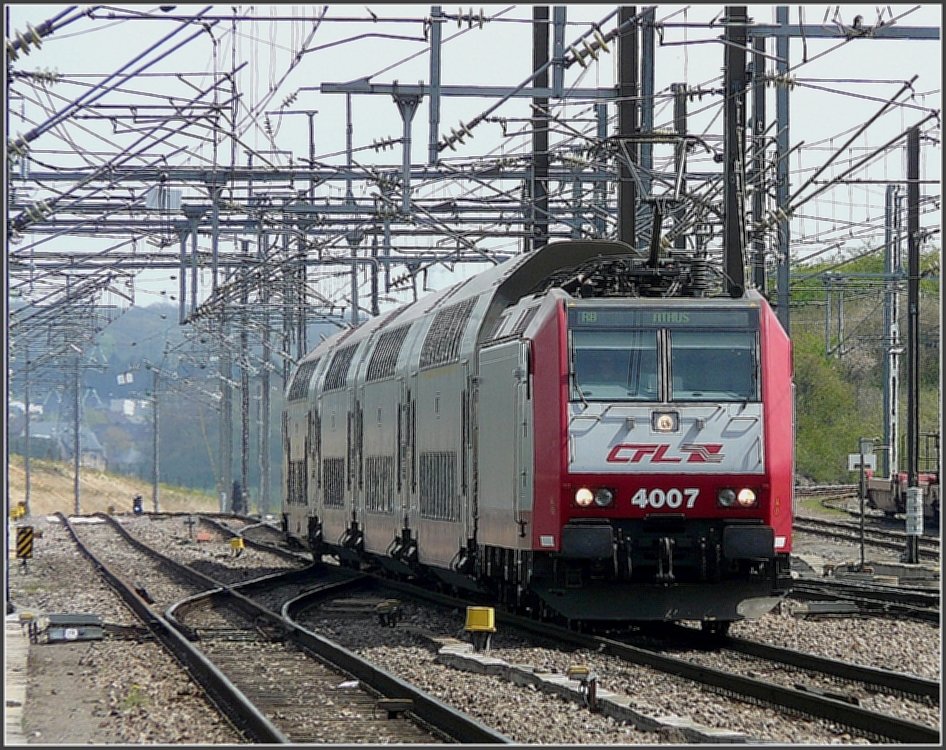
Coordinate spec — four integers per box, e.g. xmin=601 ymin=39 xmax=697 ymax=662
xmin=532 ymin=293 xmax=793 ymax=629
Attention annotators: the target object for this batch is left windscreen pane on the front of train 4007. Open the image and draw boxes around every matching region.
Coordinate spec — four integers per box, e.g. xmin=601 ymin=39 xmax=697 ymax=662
xmin=572 ymin=330 xmax=657 ymax=401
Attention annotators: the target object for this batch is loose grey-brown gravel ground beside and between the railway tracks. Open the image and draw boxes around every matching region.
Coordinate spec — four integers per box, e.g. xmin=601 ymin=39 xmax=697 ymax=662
xmin=10 ymin=518 xmax=941 ymax=745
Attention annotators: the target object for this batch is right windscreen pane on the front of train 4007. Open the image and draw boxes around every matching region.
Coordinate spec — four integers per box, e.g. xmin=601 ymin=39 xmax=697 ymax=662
xmin=670 ymin=330 xmax=759 ymax=401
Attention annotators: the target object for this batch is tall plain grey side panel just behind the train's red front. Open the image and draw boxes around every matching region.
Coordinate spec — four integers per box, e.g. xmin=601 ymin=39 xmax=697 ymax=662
xmin=475 ymin=341 xmax=533 ymax=548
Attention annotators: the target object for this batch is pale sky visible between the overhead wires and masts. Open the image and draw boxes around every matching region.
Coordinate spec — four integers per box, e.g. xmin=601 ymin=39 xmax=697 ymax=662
xmin=4 ymin=3 xmax=942 ymax=316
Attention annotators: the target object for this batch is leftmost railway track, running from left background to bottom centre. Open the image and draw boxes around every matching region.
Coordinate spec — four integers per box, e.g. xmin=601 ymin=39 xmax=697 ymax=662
xmin=62 ymin=516 xmax=508 ymax=744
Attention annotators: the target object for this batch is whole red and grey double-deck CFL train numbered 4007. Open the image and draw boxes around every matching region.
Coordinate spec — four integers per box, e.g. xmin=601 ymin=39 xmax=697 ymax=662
xmin=283 ymin=241 xmax=794 ymax=631
